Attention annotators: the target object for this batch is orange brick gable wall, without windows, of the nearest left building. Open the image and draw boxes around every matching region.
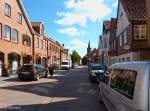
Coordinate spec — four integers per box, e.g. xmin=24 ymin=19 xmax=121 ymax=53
xmin=0 ymin=0 xmax=33 ymax=66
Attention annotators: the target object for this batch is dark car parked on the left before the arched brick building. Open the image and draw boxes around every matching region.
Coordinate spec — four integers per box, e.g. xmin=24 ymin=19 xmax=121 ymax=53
xmin=18 ymin=64 xmax=48 ymax=80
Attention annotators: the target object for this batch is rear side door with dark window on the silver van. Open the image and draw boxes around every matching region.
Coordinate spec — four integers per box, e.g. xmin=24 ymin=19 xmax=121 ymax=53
xmin=109 ymin=69 xmax=137 ymax=111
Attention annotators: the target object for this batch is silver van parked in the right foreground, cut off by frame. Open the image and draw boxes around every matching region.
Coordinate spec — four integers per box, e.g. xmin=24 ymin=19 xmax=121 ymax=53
xmin=99 ymin=62 xmax=150 ymax=111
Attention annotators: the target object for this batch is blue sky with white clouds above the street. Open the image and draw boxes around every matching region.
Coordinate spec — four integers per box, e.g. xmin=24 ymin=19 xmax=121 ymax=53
xmin=22 ymin=0 xmax=118 ymax=56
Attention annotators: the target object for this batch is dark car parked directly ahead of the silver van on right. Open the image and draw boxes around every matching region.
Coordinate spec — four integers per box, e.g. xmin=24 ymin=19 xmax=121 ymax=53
xmin=89 ymin=64 xmax=107 ymax=82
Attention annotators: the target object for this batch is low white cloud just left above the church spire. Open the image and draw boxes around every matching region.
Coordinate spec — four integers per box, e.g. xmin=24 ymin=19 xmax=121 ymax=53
xmin=69 ymin=39 xmax=87 ymax=49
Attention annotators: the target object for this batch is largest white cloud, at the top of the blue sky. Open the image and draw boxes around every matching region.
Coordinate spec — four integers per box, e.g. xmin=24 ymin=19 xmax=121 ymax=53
xmin=55 ymin=0 xmax=112 ymax=27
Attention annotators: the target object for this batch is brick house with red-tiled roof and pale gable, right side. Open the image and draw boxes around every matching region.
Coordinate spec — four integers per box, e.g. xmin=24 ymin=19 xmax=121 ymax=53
xmin=116 ymin=0 xmax=150 ymax=62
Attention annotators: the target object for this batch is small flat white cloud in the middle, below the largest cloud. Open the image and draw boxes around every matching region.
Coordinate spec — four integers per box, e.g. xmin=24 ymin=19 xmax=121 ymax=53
xmin=58 ymin=27 xmax=85 ymax=37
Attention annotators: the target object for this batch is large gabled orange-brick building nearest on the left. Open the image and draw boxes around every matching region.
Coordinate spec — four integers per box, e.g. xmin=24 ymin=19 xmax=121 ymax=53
xmin=0 ymin=0 xmax=34 ymax=75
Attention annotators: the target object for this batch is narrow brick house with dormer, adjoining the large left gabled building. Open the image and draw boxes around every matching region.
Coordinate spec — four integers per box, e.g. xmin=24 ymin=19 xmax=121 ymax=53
xmin=31 ymin=22 xmax=48 ymax=66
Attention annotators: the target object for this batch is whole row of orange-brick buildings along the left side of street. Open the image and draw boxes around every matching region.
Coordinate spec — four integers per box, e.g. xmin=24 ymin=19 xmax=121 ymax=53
xmin=0 ymin=0 xmax=68 ymax=76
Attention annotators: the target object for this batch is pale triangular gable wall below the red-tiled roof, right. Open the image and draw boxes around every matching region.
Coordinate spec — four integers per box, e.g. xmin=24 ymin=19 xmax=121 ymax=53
xmin=116 ymin=1 xmax=130 ymax=37
